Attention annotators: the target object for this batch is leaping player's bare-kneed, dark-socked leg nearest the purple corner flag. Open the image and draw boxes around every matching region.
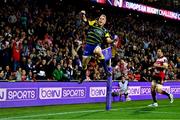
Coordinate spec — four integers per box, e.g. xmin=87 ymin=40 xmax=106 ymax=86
xmin=94 ymin=46 xmax=111 ymax=76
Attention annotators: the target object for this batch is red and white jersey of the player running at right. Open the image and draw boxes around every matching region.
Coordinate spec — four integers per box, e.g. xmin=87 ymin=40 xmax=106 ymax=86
xmin=155 ymin=56 xmax=168 ymax=73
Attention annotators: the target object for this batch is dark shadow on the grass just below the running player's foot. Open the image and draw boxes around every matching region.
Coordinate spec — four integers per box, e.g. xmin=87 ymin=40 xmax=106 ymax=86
xmin=133 ymin=107 xmax=156 ymax=114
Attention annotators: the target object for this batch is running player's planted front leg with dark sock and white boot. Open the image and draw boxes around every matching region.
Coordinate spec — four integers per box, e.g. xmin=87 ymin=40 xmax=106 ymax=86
xmin=148 ymin=80 xmax=158 ymax=107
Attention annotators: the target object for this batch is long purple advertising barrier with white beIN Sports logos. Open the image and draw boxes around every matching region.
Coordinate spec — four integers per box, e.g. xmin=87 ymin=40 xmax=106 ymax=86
xmin=0 ymin=82 xmax=180 ymax=108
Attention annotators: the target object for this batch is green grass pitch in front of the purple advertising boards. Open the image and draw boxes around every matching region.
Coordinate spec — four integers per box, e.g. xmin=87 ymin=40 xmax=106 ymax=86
xmin=0 ymin=99 xmax=180 ymax=120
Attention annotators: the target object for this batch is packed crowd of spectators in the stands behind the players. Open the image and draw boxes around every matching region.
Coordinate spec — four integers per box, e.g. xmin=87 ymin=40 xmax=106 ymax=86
xmin=0 ymin=0 xmax=180 ymax=81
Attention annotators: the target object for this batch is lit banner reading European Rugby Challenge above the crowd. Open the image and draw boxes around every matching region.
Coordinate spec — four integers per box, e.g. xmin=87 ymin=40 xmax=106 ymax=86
xmin=91 ymin=0 xmax=180 ymax=20
